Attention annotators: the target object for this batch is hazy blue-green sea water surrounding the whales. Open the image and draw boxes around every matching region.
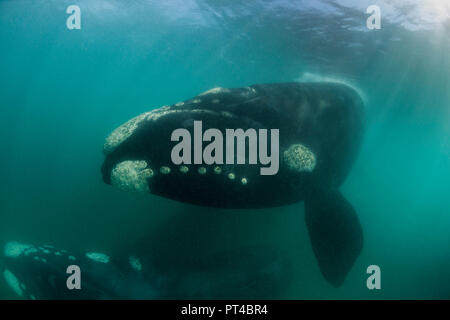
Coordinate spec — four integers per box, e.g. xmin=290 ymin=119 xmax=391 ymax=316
xmin=0 ymin=0 xmax=450 ymax=299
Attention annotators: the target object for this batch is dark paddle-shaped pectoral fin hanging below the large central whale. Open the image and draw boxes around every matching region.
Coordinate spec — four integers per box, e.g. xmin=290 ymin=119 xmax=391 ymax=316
xmin=305 ymin=190 xmax=363 ymax=287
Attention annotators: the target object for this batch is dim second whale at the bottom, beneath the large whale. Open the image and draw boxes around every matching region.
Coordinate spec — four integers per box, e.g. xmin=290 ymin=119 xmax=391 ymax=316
xmin=0 ymin=241 xmax=291 ymax=300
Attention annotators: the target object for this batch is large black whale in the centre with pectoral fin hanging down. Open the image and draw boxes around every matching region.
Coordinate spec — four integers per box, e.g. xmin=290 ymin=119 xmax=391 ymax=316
xmin=102 ymin=83 xmax=364 ymax=286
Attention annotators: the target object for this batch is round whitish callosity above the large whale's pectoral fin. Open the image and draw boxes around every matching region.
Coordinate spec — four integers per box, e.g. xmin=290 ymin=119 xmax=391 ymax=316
xmin=283 ymin=144 xmax=316 ymax=172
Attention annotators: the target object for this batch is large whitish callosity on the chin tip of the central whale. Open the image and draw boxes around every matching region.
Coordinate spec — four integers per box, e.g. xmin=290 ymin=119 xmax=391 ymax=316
xmin=111 ymin=160 xmax=153 ymax=192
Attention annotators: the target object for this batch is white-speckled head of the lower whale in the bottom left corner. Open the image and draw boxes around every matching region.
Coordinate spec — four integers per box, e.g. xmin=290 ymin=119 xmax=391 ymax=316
xmin=0 ymin=241 xmax=159 ymax=300
